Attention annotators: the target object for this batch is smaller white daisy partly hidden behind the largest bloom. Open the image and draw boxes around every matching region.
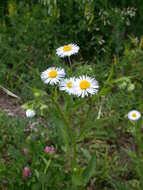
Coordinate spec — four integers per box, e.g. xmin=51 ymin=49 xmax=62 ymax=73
xmin=60 ymin=77 xmax=75 ymax=95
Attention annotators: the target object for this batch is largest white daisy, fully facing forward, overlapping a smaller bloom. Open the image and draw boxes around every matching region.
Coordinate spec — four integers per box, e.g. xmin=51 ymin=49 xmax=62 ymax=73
xmin=75 ymin=75 xmax=99 ymax=98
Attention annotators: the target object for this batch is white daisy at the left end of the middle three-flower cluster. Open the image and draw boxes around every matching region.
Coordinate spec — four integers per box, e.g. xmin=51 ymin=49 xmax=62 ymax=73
xmin=41 ymin=67 xmax=66 ymax=85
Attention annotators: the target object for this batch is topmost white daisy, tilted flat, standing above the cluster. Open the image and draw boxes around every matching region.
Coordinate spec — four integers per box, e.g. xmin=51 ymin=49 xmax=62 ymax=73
xmin=56 ymin=44 xmax=79 ymax=57
